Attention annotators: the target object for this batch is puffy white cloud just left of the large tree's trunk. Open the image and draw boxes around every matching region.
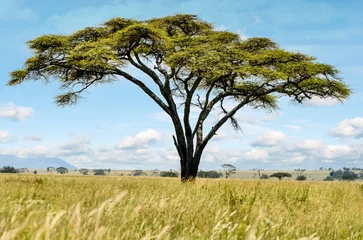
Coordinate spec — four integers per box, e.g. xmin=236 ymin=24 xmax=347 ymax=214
xmin=116 ymin=129 xmax=162 ymax=149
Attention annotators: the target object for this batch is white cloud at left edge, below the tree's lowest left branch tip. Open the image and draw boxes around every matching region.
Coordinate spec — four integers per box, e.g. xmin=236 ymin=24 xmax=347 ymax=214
xmin=0 ymin=102 xmax=34 ymax=121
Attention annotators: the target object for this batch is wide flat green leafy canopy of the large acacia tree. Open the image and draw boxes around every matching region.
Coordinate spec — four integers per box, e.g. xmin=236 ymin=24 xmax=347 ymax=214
xmin=8 ymin=14 xmax=351 ymax=108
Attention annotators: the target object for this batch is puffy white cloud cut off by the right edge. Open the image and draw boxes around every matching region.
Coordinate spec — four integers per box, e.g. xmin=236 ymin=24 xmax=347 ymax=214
xmin=330 ymin=117 xmax=363 ymax=138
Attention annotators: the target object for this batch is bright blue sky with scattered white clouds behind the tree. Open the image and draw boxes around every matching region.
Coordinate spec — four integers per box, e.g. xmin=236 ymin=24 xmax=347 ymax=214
xmin=0 ymin=0 xmax=363 ymax=169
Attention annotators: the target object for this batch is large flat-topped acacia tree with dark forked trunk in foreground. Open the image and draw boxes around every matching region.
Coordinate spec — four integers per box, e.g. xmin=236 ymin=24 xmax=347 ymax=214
xmin=8 ymin=14 xmax=351 ymax=181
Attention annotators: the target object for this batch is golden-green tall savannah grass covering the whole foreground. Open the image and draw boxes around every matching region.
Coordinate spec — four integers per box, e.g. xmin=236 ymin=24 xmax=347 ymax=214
xmin=0 ymin=174 xmax=363 ymax=240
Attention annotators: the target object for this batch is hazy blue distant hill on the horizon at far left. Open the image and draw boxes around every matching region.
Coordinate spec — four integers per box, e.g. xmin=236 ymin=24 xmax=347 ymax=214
xmin=0 ymin=154 xmax=76 ymax=169
